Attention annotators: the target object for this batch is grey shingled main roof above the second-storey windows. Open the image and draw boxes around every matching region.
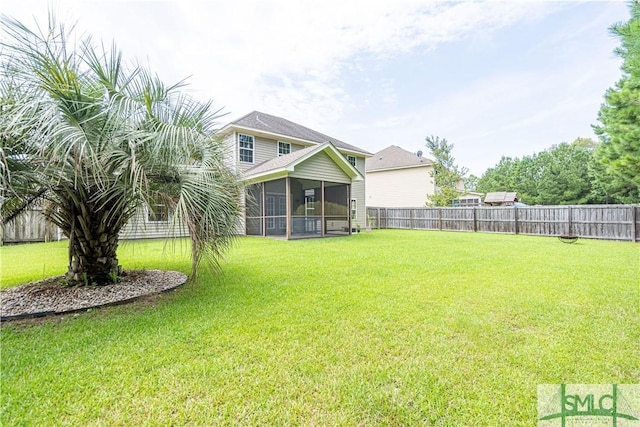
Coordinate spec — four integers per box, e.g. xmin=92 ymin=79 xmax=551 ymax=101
xmin=222 ymin=111 xmax=371 ymax=156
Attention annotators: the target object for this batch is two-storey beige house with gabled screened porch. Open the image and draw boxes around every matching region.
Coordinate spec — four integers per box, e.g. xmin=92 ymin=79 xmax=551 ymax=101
xmin=218 ymin=111 xmax=371 ymax=239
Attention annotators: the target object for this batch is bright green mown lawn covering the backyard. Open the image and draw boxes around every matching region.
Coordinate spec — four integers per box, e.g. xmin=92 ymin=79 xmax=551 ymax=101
xmin=0 ymin=230 xmax=640 ymax=425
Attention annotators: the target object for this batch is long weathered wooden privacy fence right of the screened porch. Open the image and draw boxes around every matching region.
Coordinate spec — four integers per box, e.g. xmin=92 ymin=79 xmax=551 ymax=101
xmin=367 ymin=205 xmax=640 ymax=242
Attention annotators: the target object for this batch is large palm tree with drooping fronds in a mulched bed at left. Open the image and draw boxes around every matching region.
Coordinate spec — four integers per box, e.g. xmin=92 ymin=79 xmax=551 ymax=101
xmin=0 ymin=16 xmax=240 ymax=284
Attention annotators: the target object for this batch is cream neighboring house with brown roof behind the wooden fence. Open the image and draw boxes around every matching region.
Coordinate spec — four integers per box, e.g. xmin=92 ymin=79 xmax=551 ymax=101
xmin=366 ymin=145 xmax=435 ymax=208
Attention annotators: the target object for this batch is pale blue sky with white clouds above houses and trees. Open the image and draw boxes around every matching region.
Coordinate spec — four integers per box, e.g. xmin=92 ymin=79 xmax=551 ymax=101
xmin=0 ymin=0 xmax=629 ymax=176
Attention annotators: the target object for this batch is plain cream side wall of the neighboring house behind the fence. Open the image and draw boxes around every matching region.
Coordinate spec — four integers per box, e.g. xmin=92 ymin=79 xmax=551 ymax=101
xmin=366 ymin=166 xmax=434 ymax=208
